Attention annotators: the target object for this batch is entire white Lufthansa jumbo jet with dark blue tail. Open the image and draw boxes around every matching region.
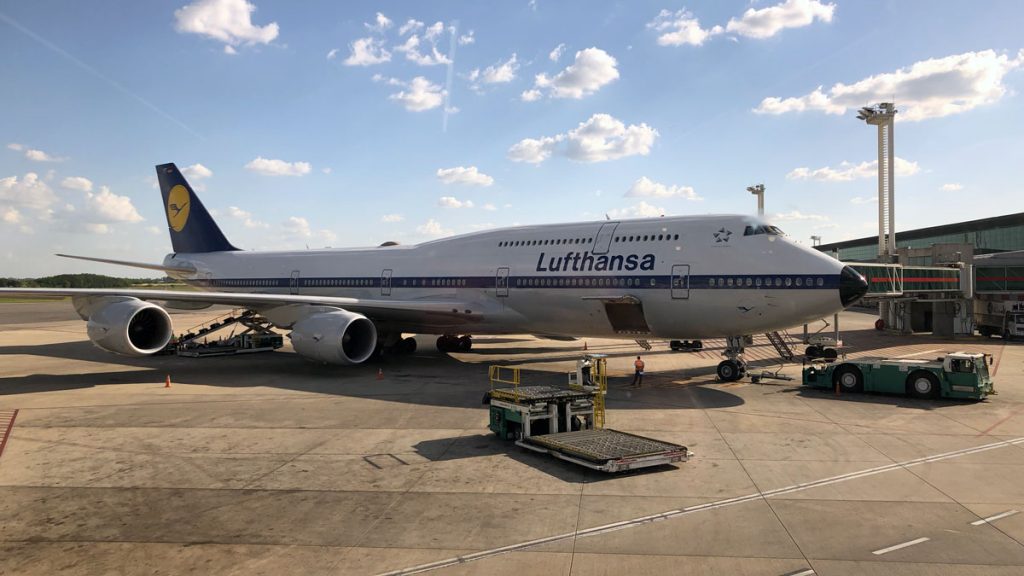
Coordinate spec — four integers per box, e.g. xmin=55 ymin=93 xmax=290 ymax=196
xmin=0 ymin=163 xmax=867 ymax=381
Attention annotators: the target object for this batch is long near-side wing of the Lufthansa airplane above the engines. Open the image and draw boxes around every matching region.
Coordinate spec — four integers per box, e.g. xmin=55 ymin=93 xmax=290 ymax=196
xmin=0 ymin=288 xmax=485 ymax=324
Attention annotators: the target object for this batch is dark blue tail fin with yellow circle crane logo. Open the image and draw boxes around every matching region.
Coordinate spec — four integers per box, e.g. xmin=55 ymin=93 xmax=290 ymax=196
xmin=157 ymin=163 xmax=238 ymax=252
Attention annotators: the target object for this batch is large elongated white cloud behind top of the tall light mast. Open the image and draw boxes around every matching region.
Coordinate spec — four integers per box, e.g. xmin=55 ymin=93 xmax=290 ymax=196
xmin=754 ymin=49 xmax=1024 ymax=121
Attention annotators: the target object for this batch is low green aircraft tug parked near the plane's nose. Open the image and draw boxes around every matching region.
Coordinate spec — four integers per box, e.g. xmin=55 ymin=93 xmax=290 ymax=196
xmin=803 ymin=352 xmax=995 ymax=400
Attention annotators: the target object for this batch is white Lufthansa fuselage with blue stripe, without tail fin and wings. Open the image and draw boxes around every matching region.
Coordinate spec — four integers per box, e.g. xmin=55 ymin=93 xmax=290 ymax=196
xmin=165 ymin=216 xmax=844 ymax=338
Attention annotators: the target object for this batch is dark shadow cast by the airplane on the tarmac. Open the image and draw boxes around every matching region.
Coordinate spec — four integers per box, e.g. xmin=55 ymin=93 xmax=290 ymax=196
xmin=0 ymin=341 xmax=743 ymax=409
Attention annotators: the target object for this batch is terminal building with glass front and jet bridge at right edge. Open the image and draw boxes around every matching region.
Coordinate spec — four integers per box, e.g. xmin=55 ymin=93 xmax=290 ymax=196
xmin=816 ymin=212 xmax=1024 ymax=336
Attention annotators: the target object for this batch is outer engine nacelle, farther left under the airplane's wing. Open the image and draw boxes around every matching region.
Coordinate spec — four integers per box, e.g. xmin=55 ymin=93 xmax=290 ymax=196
xmin=86 ymin=298 xmax=174 ymax=356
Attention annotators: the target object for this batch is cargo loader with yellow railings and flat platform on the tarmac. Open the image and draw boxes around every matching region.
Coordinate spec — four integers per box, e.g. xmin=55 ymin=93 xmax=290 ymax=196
xmin=486 ymin=363 xmax=690 ymax=472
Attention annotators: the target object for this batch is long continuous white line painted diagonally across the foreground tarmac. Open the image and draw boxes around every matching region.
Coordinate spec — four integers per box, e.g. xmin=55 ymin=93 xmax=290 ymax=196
xmin=381 ymin=437 xmax=1024 ymax=576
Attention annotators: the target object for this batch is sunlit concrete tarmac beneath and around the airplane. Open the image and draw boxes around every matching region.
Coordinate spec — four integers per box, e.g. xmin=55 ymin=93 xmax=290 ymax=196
xmin=0 ymin=301 xmax=1024 ymax=576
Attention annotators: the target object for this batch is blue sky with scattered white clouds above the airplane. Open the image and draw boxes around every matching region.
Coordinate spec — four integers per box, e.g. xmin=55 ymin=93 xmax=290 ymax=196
xmin=0 ymin=0 xmax=1024 ymax=277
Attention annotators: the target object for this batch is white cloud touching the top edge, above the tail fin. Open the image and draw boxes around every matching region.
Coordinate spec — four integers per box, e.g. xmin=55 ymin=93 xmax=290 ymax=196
xmin=174 ymin=0 xmax=280 ymax=49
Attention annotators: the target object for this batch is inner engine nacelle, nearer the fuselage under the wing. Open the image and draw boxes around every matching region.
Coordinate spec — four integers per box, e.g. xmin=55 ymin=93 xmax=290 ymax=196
xmin=291 ymin=308 xmax=377 ymax=365
